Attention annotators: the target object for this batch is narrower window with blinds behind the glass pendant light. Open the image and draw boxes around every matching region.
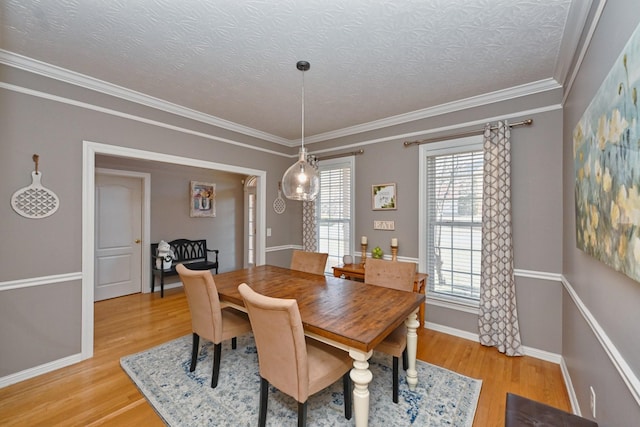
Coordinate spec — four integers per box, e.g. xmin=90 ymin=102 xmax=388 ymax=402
xmin=316 ymin=157 xmax=354 ymax=273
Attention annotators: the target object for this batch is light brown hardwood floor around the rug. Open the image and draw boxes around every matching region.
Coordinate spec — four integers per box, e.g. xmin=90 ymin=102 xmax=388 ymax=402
xmin=0 ymin=289 xmax=571 ymax=427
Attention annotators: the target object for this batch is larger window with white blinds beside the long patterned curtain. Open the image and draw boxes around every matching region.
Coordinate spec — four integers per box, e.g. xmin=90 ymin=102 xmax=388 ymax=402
xmin=420 ymin=136 xmax=483 ymax=303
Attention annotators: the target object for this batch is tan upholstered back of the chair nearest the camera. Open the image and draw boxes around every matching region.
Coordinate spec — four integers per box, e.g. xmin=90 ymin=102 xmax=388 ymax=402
xmin=238 ymin=283 xmax=309 ymax=402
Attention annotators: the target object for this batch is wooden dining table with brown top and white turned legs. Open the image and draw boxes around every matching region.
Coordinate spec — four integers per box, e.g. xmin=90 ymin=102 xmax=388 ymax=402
xmin=214 ymin=265 xmax=425 ymax=427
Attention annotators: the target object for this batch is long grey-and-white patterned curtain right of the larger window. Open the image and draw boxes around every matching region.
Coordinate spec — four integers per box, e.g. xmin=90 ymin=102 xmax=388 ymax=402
xmin=478 ymin=122 xmax=523 ymax=356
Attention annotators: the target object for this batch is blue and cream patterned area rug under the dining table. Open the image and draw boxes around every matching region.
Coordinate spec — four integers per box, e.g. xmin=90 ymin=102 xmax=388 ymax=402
xmin=120 ymin=335 xmax=482 ymax=427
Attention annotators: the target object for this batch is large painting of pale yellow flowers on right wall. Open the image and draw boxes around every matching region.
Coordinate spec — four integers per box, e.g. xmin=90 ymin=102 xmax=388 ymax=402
xmin=573 ymin=21 xmax=640 ymax=281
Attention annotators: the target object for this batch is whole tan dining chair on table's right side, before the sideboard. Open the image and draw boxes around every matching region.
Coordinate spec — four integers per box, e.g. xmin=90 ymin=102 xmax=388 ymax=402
xmin=364 ymin=258 xmax=416 ymax=403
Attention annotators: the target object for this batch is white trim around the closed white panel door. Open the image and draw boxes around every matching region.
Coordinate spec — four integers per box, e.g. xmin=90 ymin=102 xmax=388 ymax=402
xmin=94 ymin=168 xmax=151 ymax=293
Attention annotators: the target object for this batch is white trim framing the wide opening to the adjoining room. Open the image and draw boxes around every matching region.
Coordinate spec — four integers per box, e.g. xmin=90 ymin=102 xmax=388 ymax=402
xmin=81 ymin=141 xmax=267 ymax=360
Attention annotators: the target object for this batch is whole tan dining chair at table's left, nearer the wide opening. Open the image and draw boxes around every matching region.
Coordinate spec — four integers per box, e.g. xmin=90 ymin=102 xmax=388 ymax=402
xmin=176 ymin=264 xmax=251 ymax=388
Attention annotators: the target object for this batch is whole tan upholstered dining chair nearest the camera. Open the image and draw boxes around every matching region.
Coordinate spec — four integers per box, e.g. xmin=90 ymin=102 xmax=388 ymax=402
xmin=238 ymin=283 xmax=352 ymax=427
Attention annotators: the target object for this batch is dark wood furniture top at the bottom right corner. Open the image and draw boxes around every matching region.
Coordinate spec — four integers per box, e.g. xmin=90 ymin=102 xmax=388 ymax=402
xmin=504 ymin=393 xmax=598 ymax=427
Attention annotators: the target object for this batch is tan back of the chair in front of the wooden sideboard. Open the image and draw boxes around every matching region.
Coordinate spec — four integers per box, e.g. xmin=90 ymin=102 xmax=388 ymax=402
xmin=364 ymin=258 xmax=416 ymax=292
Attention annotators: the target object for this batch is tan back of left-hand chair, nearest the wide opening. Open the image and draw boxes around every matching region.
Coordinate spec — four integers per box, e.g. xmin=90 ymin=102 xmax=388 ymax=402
xmin=176 ymin=264 xmax=222 ymax=344
